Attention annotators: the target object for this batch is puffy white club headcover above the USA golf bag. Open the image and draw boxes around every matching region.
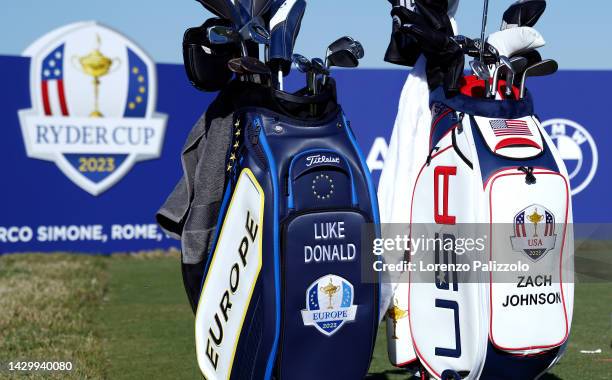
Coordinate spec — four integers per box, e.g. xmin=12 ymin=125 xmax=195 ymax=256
xmin=487 ymin=26 xmax=546 ymax=57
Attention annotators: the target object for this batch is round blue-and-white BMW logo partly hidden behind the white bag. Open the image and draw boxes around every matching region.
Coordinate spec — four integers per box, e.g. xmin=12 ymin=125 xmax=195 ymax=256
xmin=542 ymin=119 xmax=598 ymax=195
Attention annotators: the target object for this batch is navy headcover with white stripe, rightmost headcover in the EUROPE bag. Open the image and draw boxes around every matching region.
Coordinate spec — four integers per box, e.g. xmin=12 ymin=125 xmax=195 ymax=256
xmin=269 ymin=0 xmax=306 ymax=75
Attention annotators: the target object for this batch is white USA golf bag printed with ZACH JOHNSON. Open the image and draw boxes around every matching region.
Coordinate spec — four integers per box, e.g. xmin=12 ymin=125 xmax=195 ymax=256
xmin=383 ymin=84 xmax=574 ymax=380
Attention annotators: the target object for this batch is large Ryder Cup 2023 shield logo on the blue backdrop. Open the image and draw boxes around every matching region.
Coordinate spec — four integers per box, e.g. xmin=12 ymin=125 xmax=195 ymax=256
xmin=19 ymin=22 xmax=166 ymax=195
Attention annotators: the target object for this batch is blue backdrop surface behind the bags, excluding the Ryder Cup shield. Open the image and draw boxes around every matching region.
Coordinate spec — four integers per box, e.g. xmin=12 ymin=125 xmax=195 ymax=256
xmin=0 ymin=56 xmax=612 ymax=253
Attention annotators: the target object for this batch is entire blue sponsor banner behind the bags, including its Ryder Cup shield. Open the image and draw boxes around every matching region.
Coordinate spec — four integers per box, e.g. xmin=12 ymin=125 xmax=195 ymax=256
xmin=0 ymin=22 xmax=612 ymax=253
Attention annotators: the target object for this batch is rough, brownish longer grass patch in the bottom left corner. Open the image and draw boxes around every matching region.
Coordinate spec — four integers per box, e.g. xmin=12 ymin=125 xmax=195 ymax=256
xmin=0 ymin=254 xmax=110 ymax=379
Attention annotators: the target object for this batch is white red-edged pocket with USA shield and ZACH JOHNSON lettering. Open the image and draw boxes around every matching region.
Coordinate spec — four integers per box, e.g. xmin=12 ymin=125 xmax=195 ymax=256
xmin=485 ymin=168 xmax=570 ymax=354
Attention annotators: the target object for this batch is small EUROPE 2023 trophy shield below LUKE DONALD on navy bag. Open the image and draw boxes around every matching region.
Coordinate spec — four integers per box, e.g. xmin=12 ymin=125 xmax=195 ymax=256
xmin=302 ymin=274 xmax=357 ymax=336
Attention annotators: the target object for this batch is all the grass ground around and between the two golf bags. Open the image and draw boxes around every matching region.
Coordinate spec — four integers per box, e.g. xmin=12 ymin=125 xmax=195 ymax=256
xmin=0 ymin=248 xmax=612 ymax=380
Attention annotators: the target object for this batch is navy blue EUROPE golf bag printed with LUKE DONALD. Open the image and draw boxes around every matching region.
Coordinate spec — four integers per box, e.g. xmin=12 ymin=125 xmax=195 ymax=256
xmin=195 ymin=80 xmax=379 ymax=380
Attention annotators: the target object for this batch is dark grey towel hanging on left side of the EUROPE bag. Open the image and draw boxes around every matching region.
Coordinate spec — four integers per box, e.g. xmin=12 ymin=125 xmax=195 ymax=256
xmin=156 ymin=110 xmax=233 ymax=264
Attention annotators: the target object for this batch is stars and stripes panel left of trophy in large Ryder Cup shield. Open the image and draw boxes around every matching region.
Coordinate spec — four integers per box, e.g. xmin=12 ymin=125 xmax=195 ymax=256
xmin=40 ymin=44 xmax=68 ymax=116
